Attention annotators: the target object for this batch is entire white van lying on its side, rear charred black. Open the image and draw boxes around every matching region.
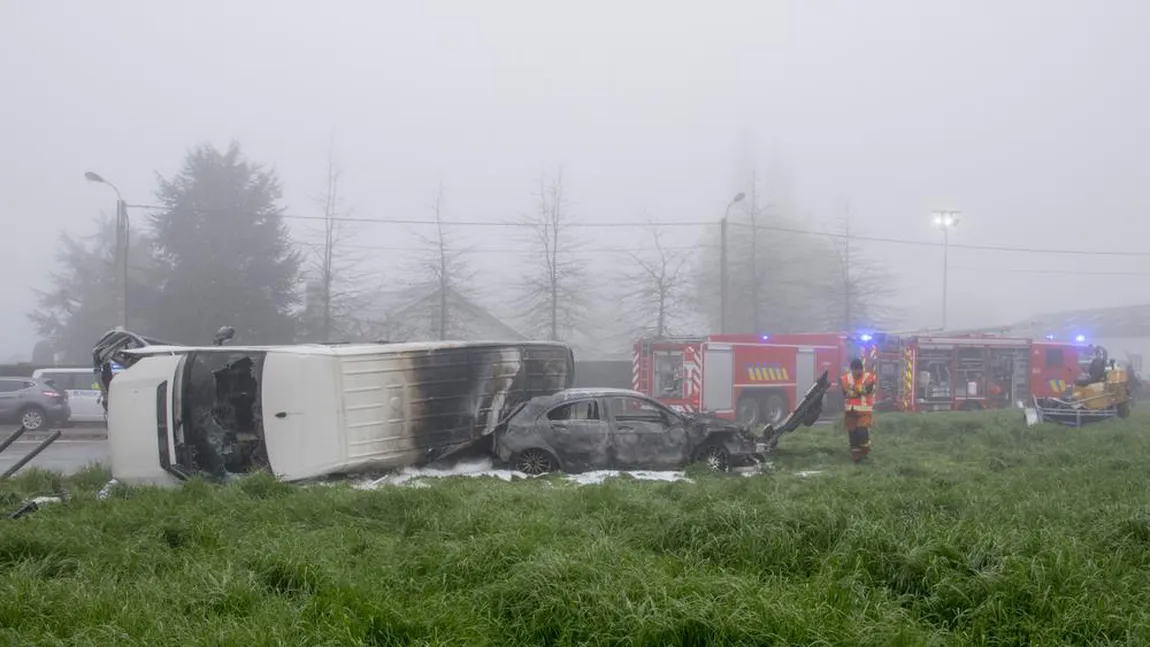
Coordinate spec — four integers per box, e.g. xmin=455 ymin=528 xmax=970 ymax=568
xmin=94 ymin=331 xmax=574 ymax=483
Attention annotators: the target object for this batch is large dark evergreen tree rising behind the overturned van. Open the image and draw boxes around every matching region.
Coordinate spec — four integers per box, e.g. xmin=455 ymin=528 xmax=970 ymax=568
xmin=152 ymin=143 xmax=300 ymax=344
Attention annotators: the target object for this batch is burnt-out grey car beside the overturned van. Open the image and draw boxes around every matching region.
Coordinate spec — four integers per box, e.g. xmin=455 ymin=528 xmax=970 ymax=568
xmin=493 ymin=388 xmax=767 ymax=475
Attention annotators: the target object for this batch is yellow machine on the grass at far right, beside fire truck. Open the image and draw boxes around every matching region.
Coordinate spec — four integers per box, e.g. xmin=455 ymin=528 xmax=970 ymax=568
xmin=1027 ymin=346 xmax=1134 ymax=428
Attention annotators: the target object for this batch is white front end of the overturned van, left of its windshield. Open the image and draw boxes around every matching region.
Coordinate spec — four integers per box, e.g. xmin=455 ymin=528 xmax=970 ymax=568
xmin=108 ymin=355 xmax=182 ymax=484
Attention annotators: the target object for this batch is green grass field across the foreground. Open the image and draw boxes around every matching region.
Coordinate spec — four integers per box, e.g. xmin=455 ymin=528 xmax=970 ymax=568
xmin=0 ymin=413 xmax=1150 ymax=647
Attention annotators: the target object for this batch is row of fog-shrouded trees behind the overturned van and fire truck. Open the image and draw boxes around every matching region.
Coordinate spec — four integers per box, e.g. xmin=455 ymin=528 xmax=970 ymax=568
xmin=30 ymin=143 xmax=897 ymax=363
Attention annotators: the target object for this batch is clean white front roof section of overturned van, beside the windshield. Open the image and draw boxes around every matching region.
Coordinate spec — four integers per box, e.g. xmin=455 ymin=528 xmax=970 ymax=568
xmin=260 ymin=351 xmax=346 ymax=480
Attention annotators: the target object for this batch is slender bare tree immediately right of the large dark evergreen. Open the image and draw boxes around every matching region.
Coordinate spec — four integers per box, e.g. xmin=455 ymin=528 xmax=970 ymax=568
xmin=304 ymin=139 xmax=368 ymax=341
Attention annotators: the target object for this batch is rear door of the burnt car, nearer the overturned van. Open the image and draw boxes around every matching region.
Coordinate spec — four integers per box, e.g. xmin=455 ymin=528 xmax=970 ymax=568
xmin=539 ymin=398 xmax=612 ymax=471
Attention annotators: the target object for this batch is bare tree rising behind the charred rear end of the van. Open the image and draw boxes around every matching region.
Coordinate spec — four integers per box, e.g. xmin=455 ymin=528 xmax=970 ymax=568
xmin=521 ymin=170 xmax=585 ymax=341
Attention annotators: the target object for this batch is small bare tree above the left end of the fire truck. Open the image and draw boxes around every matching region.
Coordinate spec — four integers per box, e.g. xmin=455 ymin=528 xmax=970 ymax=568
xmin=624 ymin=224 xmax=689 ymax=337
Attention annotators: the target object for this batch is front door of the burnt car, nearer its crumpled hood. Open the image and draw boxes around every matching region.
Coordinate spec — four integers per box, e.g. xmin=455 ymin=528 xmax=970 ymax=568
xmin=607 ymin=395 xmax=688 ymax=470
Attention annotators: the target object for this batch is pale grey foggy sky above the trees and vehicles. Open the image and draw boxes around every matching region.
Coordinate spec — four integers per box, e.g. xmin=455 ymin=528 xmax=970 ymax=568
xmin=0 ymin=0 xmax=1150 ymax=361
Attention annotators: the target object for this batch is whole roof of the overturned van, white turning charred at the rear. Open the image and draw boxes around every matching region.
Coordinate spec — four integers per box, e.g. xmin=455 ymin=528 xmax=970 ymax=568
xmin=261 ymin=344 xmax=574 ymax=480
